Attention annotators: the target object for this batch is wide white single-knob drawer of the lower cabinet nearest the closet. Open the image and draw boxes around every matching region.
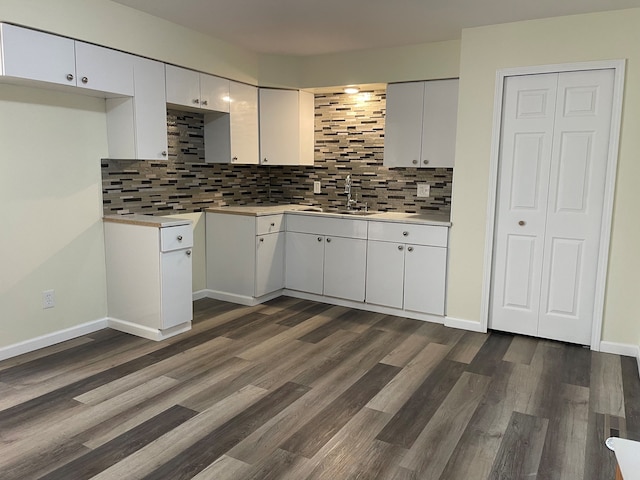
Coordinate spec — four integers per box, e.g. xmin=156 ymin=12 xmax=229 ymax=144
xmin=369 ymin=222 xmax=449 ymax=247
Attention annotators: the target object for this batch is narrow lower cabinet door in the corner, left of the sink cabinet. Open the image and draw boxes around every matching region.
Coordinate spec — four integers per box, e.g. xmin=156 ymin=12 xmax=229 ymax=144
xmin=255 ymin=233 xmax=285 ymax=297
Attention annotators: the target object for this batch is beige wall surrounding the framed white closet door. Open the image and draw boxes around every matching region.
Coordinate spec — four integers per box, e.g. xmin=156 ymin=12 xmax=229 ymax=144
xmin=448 ymin=9 xmax=640 ymax=344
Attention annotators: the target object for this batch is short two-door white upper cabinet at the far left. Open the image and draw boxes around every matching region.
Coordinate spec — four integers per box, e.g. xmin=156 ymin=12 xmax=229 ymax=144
xmin=1 ymin=24 xmax=133 ymax=96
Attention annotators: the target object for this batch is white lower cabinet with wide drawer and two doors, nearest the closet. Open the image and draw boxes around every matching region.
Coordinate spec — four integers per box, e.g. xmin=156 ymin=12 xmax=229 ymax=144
xmin=366 ymin=222 xmax=448 ymax=315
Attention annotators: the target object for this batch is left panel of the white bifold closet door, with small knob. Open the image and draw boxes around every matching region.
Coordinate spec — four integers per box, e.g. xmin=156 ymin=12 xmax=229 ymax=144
xmin=491 ymin=74 xmax=558 ymax=335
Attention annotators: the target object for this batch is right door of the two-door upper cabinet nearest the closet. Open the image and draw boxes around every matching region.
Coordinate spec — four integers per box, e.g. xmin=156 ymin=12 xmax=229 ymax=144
xmin=421 ymin=79 xmax=458 ymax=167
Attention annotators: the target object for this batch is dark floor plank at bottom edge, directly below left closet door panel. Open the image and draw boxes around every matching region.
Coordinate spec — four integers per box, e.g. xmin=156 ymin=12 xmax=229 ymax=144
xmin=488 ymin=412 xmax=549 ymax=480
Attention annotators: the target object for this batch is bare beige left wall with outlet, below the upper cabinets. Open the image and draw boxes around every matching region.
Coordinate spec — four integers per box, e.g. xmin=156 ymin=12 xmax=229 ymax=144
xmin=0 ymin=85 xmax=107 ymax=348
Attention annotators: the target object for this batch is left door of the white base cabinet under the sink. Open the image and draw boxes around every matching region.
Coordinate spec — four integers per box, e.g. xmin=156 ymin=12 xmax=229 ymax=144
xmin=285 ymin=232 xmax=324 ymax=295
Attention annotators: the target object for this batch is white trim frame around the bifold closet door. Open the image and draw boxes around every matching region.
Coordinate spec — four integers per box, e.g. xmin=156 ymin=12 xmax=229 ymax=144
xmin=480 ymin=60 xmax=626 ymax=351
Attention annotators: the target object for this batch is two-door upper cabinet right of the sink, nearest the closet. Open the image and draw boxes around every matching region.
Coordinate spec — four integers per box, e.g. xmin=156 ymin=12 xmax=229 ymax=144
xmin=384 ymin=79 xmax=458 ymax=168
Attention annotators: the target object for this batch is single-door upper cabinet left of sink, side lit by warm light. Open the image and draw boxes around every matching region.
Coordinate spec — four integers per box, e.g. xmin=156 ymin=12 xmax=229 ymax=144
xmin=260 ymin=88 xmax=314 ymax=165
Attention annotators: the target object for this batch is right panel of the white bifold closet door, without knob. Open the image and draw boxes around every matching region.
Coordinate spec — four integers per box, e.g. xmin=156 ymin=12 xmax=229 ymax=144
xmin=538 ymin=70 xmax=614 ymax=345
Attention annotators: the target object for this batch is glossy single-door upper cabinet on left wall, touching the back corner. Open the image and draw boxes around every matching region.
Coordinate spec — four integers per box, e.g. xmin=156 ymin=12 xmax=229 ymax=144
xmin=204 ymin=81 xmax=260 ymax=165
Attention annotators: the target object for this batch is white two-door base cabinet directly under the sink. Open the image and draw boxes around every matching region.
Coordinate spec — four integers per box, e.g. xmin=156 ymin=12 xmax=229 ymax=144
xmin=285 ymin=215 xmax=367 ymax=302
